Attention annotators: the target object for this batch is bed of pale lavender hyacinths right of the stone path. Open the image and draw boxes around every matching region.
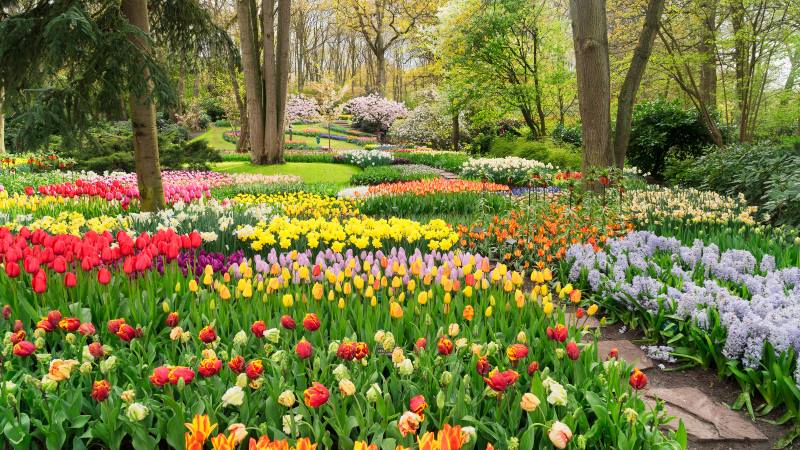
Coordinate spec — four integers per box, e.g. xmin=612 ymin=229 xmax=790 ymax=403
xmin=567 ymin=232 xmax=800 ymax=384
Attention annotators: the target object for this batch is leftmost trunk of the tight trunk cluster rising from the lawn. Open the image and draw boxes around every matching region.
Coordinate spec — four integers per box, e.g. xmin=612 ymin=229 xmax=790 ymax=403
xmin=236 ymin=0 xmax=265 ymax=162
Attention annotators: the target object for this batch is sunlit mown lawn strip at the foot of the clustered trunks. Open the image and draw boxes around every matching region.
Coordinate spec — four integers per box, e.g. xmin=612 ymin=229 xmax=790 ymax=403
xmin=213 ymin=161 xmax=361 ymax=185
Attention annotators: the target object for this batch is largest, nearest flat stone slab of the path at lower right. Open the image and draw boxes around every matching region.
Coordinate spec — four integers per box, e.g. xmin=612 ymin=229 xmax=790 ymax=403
xmin=643 ymin=387 xmax=767 ymax=442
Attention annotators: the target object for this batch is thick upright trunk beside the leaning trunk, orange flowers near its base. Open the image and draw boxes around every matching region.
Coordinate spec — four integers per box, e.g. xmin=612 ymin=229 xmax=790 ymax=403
xmin=569 ymin=0 xmax=614 ymax=190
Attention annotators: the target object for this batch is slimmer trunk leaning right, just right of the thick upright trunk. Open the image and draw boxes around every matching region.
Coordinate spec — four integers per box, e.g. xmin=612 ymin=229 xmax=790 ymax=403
xmin=614 ymin=0 xmax=664 ymax=170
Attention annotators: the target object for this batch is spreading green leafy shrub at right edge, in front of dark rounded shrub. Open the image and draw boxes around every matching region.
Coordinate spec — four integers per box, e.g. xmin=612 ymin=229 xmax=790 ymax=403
xmin=670 ymin=142 xmax=800 ymax=226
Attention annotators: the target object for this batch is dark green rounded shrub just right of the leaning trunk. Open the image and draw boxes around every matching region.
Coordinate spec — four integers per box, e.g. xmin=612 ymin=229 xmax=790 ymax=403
xmin=627 ymin=99 xmax=713 ymax=177
